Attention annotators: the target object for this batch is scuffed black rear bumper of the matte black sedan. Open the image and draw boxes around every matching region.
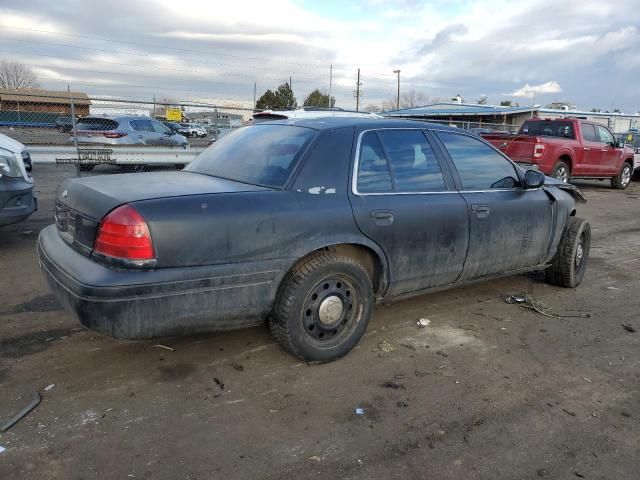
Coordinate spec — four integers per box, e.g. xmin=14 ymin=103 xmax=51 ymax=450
xmin=38 ymin=225 xmax=281 ymax=339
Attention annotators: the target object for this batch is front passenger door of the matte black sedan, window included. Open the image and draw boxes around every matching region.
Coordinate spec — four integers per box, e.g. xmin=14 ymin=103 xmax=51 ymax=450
xmin=437 ymin=131 xmax=552 ymax=281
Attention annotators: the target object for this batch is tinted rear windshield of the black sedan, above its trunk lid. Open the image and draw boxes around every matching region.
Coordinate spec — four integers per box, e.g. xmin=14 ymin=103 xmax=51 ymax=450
xmin=186 ymin=124 xmax=316 ymax=188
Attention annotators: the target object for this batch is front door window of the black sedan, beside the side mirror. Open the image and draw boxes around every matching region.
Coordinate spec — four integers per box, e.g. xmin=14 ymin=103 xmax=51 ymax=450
xmin=438 ymin=132 xmax=520 ymax=191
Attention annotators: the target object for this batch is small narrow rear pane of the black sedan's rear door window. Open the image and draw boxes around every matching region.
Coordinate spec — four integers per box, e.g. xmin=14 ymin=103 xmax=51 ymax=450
xmin=357 ymin=132 xmax=393 ymax=193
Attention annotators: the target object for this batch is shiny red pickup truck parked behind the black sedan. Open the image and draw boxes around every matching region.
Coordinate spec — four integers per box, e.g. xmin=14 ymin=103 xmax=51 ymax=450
xmin=482 ymin=118 xmax=634 ymax=189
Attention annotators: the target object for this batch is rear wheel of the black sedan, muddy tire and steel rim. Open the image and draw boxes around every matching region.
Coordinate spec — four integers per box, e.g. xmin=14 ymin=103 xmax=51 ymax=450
xmin=269 ymin=252 xmax=374 ymax=363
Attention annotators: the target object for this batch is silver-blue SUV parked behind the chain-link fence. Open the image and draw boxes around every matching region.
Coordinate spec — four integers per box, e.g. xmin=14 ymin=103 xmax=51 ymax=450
xmin=71 ymin=115 xmax=188 ymax=147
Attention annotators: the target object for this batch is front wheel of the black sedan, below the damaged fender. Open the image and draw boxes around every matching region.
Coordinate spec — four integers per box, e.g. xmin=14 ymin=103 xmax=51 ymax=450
xmin=545 ymin=217 xmax=591 ymax=288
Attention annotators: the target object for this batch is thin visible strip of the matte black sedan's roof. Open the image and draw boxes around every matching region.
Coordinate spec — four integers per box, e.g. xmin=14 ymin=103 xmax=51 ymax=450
xmin=256 ymin=116 xmax=468 ymax=133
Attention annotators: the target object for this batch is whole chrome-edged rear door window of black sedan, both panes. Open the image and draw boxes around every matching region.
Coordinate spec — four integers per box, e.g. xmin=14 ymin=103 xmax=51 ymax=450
xmin=357 ymin=130 xmax=446 ymax=193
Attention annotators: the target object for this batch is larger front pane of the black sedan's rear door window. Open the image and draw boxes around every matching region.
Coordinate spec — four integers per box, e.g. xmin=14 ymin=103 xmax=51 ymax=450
xmin=378 ymin=130 xmax=445 ymax=192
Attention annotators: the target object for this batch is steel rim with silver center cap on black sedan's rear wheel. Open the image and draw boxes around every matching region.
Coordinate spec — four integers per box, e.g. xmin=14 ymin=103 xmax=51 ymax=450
xmin=302 ymin=275 xmax=361 ymax=347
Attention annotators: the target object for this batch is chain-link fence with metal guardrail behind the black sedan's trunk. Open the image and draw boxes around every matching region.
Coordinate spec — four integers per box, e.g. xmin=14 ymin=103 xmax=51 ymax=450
xmin=0 ymin=92 xmax=252 ymax=176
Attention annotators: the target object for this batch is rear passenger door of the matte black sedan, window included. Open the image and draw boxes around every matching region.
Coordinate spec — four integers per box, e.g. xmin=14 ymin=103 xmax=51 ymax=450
xmin=350 ymin=129 xmax=469 ymax=295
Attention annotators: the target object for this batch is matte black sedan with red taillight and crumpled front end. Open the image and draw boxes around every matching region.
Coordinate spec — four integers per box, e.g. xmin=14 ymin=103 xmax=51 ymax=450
xmin=38 ymin=117 xmax=591 ymax=362
